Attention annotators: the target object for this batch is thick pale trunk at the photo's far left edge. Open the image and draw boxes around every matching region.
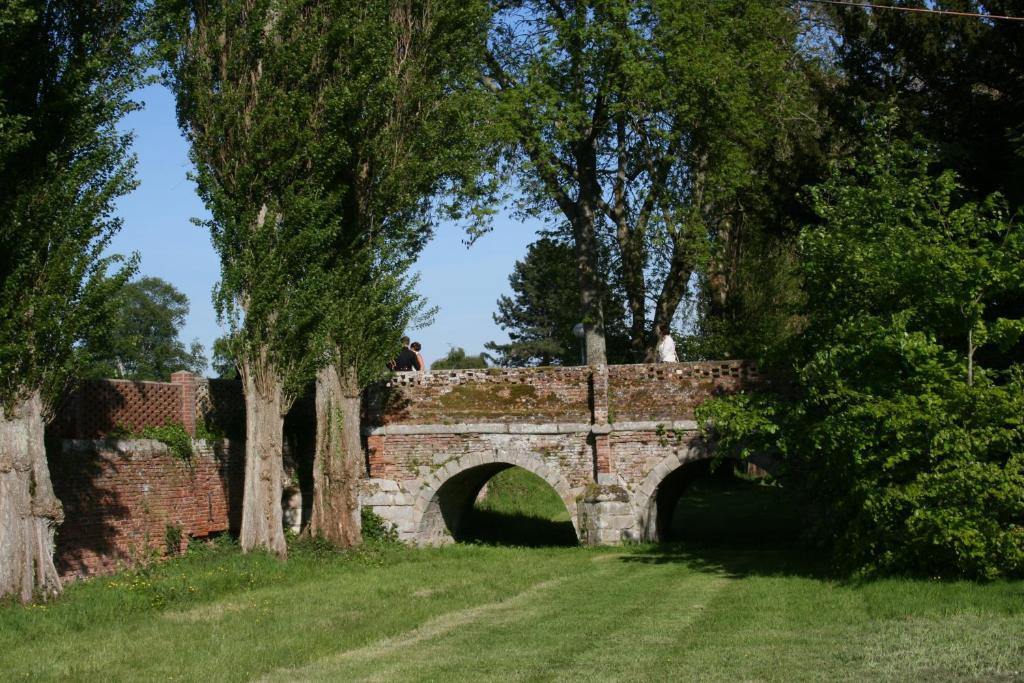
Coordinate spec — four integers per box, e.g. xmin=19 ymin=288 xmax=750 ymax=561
xmin=0 ymin=391 xmax=63 ymax=602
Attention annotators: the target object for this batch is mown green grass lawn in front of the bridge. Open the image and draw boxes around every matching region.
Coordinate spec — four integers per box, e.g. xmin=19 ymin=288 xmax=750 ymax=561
xmin=6 ymin=475 xmax=1024 ymax=681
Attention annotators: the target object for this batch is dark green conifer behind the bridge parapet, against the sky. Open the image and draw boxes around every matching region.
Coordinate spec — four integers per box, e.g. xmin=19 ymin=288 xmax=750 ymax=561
xmin=484 ymin=237 xmax=629 ymax=367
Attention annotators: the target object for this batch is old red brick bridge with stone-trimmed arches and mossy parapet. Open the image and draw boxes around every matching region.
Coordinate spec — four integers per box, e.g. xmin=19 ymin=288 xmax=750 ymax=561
xmin=360 ymin=361 xmax=760 ymax=545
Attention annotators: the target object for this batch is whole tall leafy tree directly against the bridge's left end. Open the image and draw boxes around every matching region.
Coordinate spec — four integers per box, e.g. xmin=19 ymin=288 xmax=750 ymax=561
xmin=303 ymin=0 xmax=489 ymax=546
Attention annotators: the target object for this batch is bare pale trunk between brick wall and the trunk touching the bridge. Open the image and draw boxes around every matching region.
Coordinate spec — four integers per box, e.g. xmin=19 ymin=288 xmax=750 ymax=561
xmin=241 ymin=352 xmax=288 ymax=559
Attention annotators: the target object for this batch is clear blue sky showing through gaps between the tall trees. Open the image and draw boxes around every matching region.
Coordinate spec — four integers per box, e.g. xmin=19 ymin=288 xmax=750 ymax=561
xmin=111 ymin=85 xmax=540 ymax=374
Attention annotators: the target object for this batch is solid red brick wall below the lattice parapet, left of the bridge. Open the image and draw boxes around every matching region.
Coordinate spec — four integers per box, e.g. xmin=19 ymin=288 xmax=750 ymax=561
xmin=49 ymin=440 xmax=244 ymax=579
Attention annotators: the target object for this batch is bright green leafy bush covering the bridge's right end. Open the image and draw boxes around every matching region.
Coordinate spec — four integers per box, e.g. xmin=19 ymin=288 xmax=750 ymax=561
xmin=699 ymin=121 xmax=1024 ymax=579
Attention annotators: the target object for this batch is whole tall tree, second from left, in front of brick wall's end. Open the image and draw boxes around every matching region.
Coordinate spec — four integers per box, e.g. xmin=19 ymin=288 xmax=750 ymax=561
xmin=154 ymin=0 xmax=337 ymax=557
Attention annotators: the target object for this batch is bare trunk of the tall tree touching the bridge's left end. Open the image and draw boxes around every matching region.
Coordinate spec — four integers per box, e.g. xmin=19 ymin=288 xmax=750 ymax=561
xmin=310 ymin=364 xmax=362 ymax=548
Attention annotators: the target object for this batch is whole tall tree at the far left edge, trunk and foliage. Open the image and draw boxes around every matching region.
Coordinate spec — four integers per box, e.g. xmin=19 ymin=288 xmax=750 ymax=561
xmin=0 ymin=0 xmax=141 ymax=602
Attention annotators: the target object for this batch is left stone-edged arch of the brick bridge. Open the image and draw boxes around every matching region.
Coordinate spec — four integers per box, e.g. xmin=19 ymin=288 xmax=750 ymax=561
xmin=413 ymin=451 xmax=580 ymax=546
